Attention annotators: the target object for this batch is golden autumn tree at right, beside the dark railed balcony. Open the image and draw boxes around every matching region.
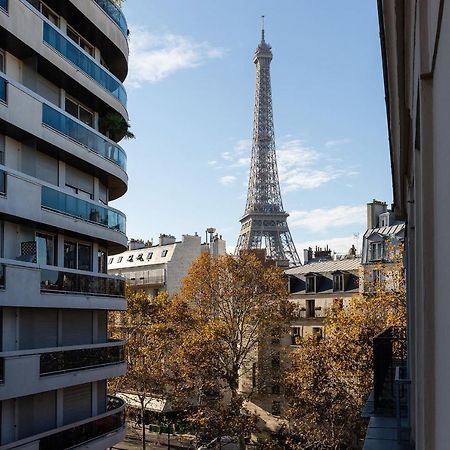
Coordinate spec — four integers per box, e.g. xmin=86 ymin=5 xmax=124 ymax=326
xmin=286 ymin=248 xmax=406 ymax=450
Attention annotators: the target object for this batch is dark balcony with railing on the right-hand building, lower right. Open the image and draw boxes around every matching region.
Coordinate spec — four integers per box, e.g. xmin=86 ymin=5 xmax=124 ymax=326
xmin=363 ymin=327 xmax=412 ymax=450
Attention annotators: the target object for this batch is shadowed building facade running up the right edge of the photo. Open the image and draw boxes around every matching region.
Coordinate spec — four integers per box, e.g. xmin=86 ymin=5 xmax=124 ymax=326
xmin=364 ymin=0 xmax=450 ymax=450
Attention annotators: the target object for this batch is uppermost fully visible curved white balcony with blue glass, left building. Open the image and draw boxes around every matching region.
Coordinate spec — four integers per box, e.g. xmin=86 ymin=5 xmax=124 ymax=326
xmin=0 ymin=0 xmax=128 ymax=120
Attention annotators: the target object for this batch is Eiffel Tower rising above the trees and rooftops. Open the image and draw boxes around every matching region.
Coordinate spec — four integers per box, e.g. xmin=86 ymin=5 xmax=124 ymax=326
xmin=235 ymin=20 xmax=301 ymax=266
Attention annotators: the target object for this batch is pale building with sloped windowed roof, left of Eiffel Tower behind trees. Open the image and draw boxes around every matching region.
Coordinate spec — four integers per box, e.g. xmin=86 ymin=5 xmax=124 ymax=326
xmin=108 ymin=234 xmax=226 ymax=296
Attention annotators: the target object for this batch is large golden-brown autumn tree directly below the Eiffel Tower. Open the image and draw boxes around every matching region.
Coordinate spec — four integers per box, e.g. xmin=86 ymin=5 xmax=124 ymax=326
xmin=165 ymin=252 xmax=291 ymax=444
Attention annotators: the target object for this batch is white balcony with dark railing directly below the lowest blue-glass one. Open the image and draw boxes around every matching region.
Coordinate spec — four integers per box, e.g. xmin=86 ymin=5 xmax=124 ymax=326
xmin=0 ymin=258 xmax=126 ymax=311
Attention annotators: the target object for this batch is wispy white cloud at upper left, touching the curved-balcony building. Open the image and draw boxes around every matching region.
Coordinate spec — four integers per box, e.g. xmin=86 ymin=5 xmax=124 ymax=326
xmin=126 ymin=26 xmax=226 ymax=88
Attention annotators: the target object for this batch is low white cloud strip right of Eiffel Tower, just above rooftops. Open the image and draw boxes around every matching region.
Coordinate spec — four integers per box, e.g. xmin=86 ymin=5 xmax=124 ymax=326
xmin=289 ymin=205 xmax=366 ymax=232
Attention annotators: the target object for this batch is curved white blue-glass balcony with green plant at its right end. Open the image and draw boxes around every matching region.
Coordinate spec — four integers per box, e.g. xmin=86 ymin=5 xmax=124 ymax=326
xmin=0 ymin=78 xmax=128 ymax=200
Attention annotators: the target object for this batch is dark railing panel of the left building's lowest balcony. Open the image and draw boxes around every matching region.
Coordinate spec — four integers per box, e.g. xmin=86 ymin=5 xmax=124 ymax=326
xmin=39 ymin=396 xmax=125 ymax=450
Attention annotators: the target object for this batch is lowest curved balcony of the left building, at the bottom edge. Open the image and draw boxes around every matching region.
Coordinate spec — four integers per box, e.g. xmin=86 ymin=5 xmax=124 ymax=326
xmin=2 ymin=396 xmax=125 ymax=450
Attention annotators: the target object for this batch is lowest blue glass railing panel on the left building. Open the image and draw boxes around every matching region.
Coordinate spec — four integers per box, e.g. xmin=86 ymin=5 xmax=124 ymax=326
xmin=41 ymin=186 xmax=126 ymax=234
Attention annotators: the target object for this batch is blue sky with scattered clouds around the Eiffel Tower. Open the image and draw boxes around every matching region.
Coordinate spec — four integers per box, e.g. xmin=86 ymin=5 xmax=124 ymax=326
xmin=113 ymin=0 xmax=392 ymax=253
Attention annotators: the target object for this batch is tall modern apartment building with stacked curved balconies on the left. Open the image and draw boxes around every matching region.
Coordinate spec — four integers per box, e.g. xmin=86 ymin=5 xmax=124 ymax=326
xmin=0 ymin=0 xmax=128 ymax=449
